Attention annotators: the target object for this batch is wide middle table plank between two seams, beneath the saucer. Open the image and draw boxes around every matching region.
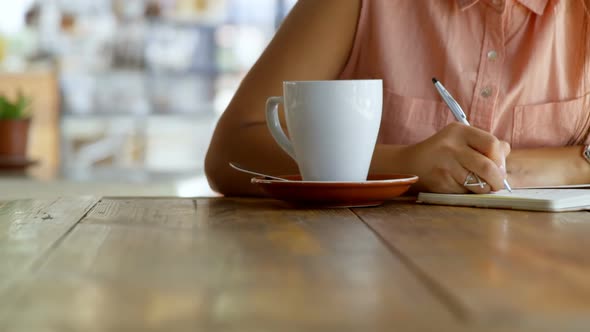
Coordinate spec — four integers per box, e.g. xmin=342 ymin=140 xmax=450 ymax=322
xmin=0 ymin=199 xmax=457 ymax=331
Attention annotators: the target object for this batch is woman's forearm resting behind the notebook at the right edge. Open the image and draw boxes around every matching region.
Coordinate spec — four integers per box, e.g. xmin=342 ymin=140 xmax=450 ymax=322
xmin=506 ymin=146 xmax=590 ymax=187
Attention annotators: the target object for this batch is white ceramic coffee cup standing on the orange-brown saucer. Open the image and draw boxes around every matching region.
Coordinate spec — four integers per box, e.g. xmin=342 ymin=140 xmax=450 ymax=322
xmin=266 ymin=80 xmax=383 ymax=182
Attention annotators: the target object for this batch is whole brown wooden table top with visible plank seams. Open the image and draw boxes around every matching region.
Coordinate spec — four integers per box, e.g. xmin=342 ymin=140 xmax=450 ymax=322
xmin=0 ymin=197 xmax=590 ymax=331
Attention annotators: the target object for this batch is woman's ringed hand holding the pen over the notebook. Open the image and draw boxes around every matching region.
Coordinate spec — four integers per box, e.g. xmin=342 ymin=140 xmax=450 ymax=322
xmin=405 ymin=122 xmax=510 ymax=193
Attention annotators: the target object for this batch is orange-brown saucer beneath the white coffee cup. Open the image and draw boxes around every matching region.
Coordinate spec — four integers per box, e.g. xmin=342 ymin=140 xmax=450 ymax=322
xmin=252 ymin=174 xmax=418 ymax=207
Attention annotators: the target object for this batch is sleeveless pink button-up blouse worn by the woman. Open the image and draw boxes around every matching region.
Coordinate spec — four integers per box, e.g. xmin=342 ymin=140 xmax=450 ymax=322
xmin=341 ymin=0 xmax=590 ymax=148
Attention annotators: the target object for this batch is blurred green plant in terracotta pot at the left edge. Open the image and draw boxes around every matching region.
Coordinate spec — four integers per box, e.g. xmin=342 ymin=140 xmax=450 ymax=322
xmin=0 ymin=91 xmax=31 ymax=159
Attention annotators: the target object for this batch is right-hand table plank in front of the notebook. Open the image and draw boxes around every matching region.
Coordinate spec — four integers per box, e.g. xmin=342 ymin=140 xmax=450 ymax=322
xmin=354 ymin=204 xmax=590 ymax=330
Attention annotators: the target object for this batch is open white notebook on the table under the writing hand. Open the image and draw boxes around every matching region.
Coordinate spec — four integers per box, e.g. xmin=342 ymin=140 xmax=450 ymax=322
xmin=417 ymin=186 xmax=590 ymax=212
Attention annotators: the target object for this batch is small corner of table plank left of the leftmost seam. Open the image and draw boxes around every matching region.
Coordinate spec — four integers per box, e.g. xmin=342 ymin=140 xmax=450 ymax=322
xmin=0 ymin=198 xmax=97 ymax=291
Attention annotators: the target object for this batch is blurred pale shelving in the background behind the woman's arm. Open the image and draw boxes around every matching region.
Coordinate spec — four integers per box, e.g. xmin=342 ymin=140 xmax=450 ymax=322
xmin=41 ymin=0 xmax=296 ymax=184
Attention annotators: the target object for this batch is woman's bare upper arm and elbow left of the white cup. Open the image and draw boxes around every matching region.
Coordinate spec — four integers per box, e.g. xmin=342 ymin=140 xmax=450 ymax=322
xmin=205 ymin=0 xmax=361 ymax=195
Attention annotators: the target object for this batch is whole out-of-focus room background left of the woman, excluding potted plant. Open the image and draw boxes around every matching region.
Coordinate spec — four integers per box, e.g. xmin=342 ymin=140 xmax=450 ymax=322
xmin=0 ymin=0 xmax=296 ymax=198
